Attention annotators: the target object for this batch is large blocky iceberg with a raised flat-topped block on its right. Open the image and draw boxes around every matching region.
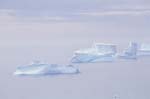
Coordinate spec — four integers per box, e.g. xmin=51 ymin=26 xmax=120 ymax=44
xmin=71 ymin=43 xmax=117 ymax=63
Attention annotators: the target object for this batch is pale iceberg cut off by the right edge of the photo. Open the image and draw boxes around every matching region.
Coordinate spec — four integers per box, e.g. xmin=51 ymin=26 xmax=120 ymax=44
xmin=137 ymin=43 xmax=150 ymax=56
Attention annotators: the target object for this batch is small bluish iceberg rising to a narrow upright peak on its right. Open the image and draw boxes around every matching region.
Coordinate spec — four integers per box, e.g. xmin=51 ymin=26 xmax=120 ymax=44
xmin=118 ymin=42 xmax=138 ymax=59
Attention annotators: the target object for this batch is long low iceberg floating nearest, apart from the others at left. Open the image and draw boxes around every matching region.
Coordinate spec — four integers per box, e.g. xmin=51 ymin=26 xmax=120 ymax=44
xmin=14 ymin=62 xmax=79 ymax=75
